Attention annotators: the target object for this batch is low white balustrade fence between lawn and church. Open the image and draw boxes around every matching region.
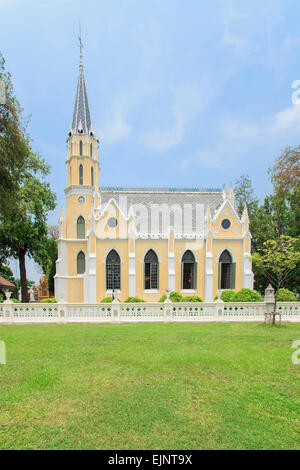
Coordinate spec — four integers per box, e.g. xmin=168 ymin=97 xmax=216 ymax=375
xmin=0 ymin=302 xmax=300 ymax=324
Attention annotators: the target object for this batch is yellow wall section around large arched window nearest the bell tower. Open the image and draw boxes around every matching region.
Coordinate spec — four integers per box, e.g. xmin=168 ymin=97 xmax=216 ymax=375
xmin=96 ymin=240 xmax=129 ymax=302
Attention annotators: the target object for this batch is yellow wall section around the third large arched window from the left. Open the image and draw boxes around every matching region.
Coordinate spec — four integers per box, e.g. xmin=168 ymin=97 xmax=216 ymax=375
xmin=174 ymin=240 xmax=205 ymax=298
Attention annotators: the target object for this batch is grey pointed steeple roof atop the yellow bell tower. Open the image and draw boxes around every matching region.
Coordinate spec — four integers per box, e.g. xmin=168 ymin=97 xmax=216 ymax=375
xmin=71 ymin=37 xmax=92 ymax=134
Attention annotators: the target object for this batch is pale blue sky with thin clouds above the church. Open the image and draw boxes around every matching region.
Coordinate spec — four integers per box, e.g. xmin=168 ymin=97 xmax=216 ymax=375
xmin=0 ymin=0 xmax=300 ymax=278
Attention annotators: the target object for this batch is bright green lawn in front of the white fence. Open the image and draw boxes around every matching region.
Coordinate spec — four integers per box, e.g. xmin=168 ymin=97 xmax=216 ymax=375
xmin=0 ymin=323 xmax=300 ymax=450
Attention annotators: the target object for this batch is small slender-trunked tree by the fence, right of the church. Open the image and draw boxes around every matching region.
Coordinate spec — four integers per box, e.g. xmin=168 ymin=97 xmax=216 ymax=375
xmin=252 ymin=235 xmax=300 ymax=318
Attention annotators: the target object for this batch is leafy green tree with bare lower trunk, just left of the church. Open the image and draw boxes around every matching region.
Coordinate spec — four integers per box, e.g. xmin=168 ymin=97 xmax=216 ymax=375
xmin=0 ymin=162 xmax=56 ymax=302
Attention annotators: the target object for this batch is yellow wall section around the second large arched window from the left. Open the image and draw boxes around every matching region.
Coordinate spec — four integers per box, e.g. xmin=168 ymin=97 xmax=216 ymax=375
xmin=135 ymin=239 xmax=168 ymax=302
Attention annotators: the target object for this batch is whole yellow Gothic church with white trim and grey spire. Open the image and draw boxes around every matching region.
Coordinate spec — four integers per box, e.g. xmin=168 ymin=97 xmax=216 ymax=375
xmin=55 ymin=57 xmax=253 ymax=303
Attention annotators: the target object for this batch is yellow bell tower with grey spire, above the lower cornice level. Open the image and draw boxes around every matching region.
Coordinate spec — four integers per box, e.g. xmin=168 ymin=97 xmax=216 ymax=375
xmin=65 ymin=37 xmax=100 ymax=239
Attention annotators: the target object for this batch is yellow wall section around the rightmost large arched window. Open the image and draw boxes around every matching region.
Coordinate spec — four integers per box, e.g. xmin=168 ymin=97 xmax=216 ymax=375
xmin=213 ymin=239 xmax=243 ymax=297
